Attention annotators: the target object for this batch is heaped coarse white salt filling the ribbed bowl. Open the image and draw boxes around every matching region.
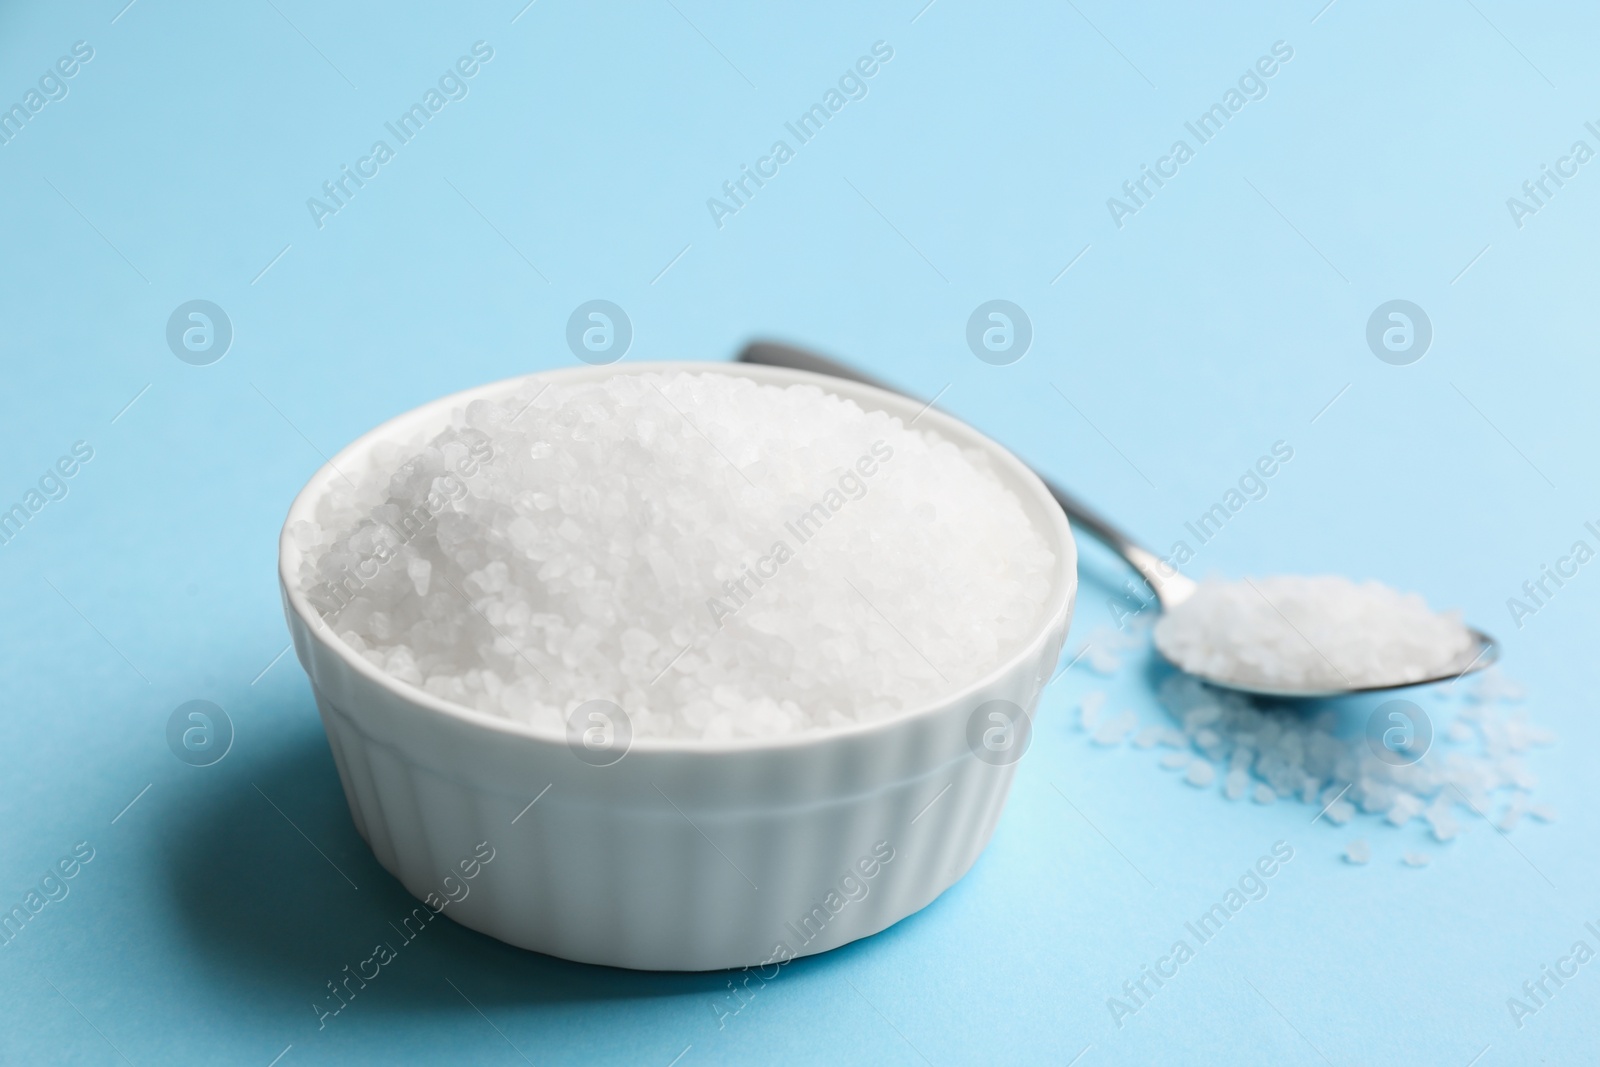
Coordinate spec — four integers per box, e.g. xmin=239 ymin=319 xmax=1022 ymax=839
xmin=290 ymin=373 xmax=1054 ymax=737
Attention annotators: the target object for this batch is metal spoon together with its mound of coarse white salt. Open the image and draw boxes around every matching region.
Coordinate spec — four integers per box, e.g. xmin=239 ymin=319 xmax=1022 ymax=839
xmin=739 ymin=341 xmax=1499 ymax=699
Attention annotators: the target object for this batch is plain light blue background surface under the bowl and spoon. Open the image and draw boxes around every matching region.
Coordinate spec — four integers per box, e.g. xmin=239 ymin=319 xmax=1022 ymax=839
xmin=0 ymin=0 xmax=1600 ymax=1067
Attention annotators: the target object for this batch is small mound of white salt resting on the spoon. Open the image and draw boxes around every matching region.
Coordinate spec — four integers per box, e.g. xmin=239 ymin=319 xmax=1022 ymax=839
xmin=1155 ymin=574 xmax=1477 ymax=693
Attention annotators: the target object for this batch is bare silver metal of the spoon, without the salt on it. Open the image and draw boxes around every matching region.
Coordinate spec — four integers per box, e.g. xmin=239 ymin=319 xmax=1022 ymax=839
xmin=738 ymin=341 xmax=1499 ymax=699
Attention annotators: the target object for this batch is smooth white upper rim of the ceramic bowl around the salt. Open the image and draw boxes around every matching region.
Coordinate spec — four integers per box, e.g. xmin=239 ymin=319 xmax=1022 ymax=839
xmin=278 ymin=360 xmax=1077 ymax=757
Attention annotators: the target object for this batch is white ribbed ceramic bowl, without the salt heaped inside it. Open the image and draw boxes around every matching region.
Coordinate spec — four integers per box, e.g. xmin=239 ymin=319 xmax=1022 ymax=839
xmin=278 ymin=363 xmax=1077 ymax=971
